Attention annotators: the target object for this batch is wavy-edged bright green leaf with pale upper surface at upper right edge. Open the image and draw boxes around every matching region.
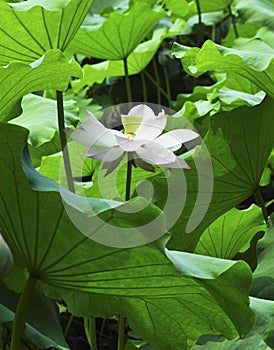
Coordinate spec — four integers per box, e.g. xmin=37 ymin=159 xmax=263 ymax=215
xmin=173 ymin=39 xmax=274 ymax=97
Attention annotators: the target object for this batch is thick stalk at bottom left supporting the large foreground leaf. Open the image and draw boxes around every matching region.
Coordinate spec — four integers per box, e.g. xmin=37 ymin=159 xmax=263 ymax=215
xmin=10 ymin=276 xmax=37 ymax=350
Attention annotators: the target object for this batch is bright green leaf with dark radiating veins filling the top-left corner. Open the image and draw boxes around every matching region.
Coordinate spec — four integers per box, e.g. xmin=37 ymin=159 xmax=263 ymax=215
xmin=0 ymin=0 xmax=93 ymax=65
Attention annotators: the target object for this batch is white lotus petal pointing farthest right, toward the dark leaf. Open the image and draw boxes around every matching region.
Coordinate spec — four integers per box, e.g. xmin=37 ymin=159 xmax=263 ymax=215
xmin=154 ymin=129 xmax=200 ymax=151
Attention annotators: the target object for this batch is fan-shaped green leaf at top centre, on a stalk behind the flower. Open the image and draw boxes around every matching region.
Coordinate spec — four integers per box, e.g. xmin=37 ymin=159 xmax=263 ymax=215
xmin=70 ymin=2 xmax=165 ymax=60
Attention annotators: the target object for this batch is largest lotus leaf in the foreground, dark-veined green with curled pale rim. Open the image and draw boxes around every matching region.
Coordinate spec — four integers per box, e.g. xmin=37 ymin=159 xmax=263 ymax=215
xmin=0 ymin=124 xmax=254 ymax=350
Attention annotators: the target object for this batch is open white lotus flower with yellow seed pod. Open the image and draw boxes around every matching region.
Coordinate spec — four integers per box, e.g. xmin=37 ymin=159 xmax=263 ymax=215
xmin=66 ymin=104 xmax=199 ymax=175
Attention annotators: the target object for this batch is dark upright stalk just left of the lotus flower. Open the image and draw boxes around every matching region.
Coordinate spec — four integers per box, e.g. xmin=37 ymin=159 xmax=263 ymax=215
xmin=56 ymin=91 xmax=75 ymax=192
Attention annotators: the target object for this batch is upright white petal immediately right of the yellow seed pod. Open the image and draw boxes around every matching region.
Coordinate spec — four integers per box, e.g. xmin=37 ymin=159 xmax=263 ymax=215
xmin=135 ymin=113 xmax=166 ymax=141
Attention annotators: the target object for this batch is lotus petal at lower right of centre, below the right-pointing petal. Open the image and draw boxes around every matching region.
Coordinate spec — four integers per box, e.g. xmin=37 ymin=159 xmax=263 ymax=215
xmin=135 ymin=142 xmax=176 ymax=165
